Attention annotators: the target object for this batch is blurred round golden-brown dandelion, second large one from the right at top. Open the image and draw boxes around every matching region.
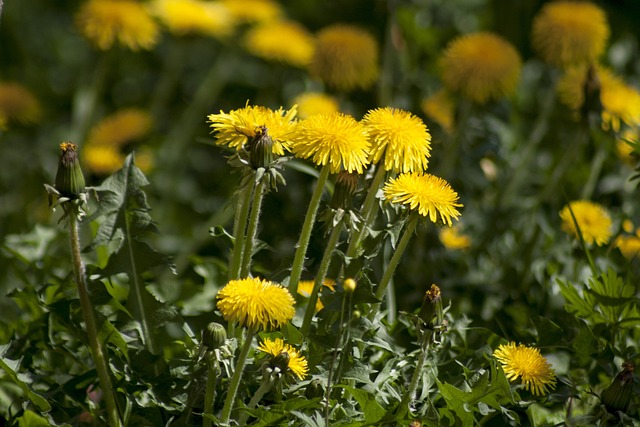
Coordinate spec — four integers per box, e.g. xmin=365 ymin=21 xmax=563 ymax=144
xmin=440 ymin=32 xmax=522 ymax=104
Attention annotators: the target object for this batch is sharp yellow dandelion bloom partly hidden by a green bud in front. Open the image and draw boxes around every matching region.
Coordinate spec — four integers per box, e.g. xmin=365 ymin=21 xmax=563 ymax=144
xmin=207 ymin=105 xmax=297 ymax=156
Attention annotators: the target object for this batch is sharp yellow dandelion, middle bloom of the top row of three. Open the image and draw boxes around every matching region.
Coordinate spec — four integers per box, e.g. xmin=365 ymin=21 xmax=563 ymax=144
xmin=291 ymin=113 xmax=371 ymax=173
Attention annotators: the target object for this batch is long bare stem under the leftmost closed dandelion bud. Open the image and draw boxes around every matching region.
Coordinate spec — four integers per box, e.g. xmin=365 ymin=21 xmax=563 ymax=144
xmin=68 ymin=208 xmax=122 ymax=427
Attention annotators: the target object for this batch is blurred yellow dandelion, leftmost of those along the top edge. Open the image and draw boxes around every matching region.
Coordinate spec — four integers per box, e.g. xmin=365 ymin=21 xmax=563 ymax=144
xmin=76 ymin=0 xmax=159 ymax=50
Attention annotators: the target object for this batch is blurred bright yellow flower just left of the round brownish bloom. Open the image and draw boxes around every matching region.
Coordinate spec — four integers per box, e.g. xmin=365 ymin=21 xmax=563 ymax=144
xmin=244 ymin=21 xmax=314 ymax=68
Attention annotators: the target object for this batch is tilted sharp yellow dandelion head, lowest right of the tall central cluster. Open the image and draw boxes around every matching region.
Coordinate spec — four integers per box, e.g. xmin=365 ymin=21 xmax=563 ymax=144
xmin=383 ymin=172 xmax=462 ymax=226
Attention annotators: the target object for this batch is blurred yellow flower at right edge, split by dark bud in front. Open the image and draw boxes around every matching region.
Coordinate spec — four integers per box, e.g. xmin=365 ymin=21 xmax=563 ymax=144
xmin=557 ymin=66 xmax=640 ymax=132
